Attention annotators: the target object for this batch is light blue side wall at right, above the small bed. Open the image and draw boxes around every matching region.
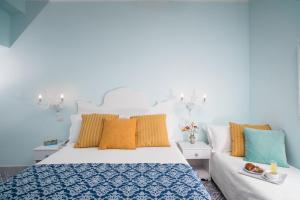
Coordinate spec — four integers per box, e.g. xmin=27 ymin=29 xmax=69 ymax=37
xmin=250 ymin=0 xmax=300 ymax=167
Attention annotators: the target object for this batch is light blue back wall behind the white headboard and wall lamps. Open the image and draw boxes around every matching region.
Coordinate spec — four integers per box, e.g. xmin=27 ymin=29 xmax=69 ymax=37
xmin=0 ymin=2 xmax=250 ymax=165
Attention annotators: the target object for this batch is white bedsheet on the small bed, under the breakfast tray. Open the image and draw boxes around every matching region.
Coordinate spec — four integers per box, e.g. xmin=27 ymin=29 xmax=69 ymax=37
xmin=211 ymin=153 xmax=300 ymax=200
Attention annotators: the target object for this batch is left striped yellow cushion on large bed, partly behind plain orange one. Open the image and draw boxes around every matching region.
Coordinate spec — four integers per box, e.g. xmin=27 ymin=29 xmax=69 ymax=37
xmin=75 ymin=114 xmax=119 ymax=148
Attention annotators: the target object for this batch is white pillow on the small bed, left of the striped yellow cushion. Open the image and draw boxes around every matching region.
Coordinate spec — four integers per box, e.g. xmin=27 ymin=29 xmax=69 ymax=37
xmin=207 ymin=125 xmax=231 ymax=152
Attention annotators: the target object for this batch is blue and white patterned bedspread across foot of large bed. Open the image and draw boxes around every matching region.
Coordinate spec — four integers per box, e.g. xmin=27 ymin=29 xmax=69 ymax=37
xmin=0 ymin=163 xmax=210 ymax=200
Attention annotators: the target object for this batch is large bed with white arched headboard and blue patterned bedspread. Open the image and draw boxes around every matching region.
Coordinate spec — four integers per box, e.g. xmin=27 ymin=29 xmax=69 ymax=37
xmin=0 ymin=88 xmax=210 ymax=200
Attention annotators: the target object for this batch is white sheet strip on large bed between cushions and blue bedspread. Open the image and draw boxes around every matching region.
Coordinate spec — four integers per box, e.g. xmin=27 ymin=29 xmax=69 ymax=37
xmin=38 ymin=143 xmax=187 ymax=164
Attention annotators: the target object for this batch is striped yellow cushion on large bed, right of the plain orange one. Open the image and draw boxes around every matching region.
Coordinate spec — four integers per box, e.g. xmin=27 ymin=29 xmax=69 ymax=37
xmin=131 ymin=114 xmax=170 ymax=147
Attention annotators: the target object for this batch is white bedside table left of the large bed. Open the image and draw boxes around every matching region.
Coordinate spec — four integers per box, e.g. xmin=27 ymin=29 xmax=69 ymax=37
xmin=33 ymin=144 xmax=63 ymax=163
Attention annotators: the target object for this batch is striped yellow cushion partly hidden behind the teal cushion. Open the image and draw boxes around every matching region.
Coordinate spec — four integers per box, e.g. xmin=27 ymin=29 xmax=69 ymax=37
xmin=229 ymin=122 xmax=271 ymax=157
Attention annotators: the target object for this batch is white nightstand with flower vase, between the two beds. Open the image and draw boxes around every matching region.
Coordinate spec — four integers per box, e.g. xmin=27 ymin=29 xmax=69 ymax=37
xmin=178 ymin=141 xmax=211 ymax=180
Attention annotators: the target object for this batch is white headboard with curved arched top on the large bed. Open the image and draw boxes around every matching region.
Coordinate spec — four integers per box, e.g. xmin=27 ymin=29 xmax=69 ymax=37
xmin=78 ymin=88 xmax=182 ymax=141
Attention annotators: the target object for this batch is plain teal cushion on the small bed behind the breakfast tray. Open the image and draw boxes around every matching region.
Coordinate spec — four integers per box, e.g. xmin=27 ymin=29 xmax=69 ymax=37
xmin=244 ymin=128 xmax=289 ymax=167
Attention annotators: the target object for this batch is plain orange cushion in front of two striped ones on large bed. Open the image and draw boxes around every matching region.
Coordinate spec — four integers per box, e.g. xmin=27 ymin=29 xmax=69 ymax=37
xmin=99 ymin=119 xmax=136 ymax=149
